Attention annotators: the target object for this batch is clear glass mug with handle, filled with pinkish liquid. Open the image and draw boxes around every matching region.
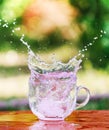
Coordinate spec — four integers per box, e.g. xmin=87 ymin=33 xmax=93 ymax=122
xmin=29 ymin=69 xmax=90 ymax=120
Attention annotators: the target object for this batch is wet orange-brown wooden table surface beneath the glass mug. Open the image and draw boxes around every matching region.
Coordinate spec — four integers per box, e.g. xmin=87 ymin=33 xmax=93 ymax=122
xmin=0 ymin=110 xmax=109 ymax=130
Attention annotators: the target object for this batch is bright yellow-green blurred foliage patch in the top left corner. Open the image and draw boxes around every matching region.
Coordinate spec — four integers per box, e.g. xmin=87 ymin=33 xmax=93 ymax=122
xmin=0 ymin=0 xmax=30 ymax=22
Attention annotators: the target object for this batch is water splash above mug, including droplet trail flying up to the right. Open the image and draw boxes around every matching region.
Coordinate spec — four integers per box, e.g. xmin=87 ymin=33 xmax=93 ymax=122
xmin=20 ymin=30 xmax=106 ymax=74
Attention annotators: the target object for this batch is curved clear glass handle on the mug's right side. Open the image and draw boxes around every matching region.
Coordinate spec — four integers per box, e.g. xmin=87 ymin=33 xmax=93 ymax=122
xmin=76 ymin=86 xmax=90 ymax=109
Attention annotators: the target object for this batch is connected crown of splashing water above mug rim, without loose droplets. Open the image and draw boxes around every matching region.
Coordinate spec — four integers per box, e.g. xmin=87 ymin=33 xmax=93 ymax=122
xmin=20 ymin=34 xmax=82 ymax=74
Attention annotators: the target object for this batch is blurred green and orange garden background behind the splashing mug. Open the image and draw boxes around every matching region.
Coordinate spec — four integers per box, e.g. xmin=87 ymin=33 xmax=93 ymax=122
xmin=0 ymin=0 xmax=109 ymax=110
